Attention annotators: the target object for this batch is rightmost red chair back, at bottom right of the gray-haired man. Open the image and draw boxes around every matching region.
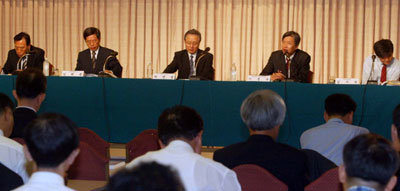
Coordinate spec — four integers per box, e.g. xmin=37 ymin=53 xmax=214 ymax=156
xmin=304 ymin=167 xmax=343 ymax=191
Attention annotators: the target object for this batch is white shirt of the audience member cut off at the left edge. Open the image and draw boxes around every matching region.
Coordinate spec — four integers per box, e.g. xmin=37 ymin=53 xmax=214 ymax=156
xmin=0 ymin=130 xmax=29 ymax=183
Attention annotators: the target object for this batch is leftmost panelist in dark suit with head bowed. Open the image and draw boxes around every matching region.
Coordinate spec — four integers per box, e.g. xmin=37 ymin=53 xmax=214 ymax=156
xmin=3 ymin=32 xmax=44 ymax=74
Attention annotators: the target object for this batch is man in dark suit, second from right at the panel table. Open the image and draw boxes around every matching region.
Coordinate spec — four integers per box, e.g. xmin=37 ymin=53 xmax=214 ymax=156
xmin=260 ymin=31 xmax=311 ymax=82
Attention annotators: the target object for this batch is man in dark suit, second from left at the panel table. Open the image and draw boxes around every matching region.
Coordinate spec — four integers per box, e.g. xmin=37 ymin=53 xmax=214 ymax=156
xmin=75 ymin=27 xmax=122 ymax=78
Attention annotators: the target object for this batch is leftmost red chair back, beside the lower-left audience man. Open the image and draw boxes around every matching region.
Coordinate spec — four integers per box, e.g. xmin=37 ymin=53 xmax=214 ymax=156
xmin=67 ymin=141 xmax=109 ymax=180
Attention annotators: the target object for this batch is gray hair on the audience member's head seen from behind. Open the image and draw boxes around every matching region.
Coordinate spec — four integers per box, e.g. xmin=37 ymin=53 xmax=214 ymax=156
xmin=240 ymin=90 xmax=286 ymax=131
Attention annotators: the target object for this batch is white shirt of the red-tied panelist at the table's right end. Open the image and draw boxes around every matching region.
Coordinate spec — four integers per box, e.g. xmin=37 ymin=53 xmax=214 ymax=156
xmin=362 ymin=56 xmax=400 ymax=84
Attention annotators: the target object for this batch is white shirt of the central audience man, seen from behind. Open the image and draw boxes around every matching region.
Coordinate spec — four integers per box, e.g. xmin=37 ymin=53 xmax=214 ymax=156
xmin=126 ymin=140 xmax=241 ymax=191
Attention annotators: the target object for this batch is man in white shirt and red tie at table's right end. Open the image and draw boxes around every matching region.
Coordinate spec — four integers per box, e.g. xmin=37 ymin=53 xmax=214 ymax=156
xmin=362 ymin=39 xmax=400 ymax=84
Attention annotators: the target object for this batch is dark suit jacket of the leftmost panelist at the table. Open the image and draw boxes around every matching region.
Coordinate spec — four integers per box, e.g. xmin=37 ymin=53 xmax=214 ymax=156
xmin=3 ymin=45 xmax=44 ymax=74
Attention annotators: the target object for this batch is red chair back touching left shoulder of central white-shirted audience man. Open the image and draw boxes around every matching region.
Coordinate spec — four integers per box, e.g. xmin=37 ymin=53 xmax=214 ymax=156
xmin=126 ymin=129 xmax=161 ymax=163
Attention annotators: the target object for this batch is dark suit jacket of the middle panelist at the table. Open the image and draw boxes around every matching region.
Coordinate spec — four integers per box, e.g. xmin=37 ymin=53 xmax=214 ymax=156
xmin=163 ymin=49 xmax=214 ymax=80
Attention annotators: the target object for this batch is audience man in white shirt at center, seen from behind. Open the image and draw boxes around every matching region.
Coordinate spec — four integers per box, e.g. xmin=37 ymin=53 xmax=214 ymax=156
xmin=127 ymin=106 xmax=241 ymax=191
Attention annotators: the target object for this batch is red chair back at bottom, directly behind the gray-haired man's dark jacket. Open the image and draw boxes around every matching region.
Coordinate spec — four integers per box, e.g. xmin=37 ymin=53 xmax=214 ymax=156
xmin=233 ymin=164 xmax=288 ymax=191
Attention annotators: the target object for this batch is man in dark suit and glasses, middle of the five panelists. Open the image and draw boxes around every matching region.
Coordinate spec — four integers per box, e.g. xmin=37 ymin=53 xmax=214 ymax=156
xmin=163 ymin=29 xmax=214 ymax=80
